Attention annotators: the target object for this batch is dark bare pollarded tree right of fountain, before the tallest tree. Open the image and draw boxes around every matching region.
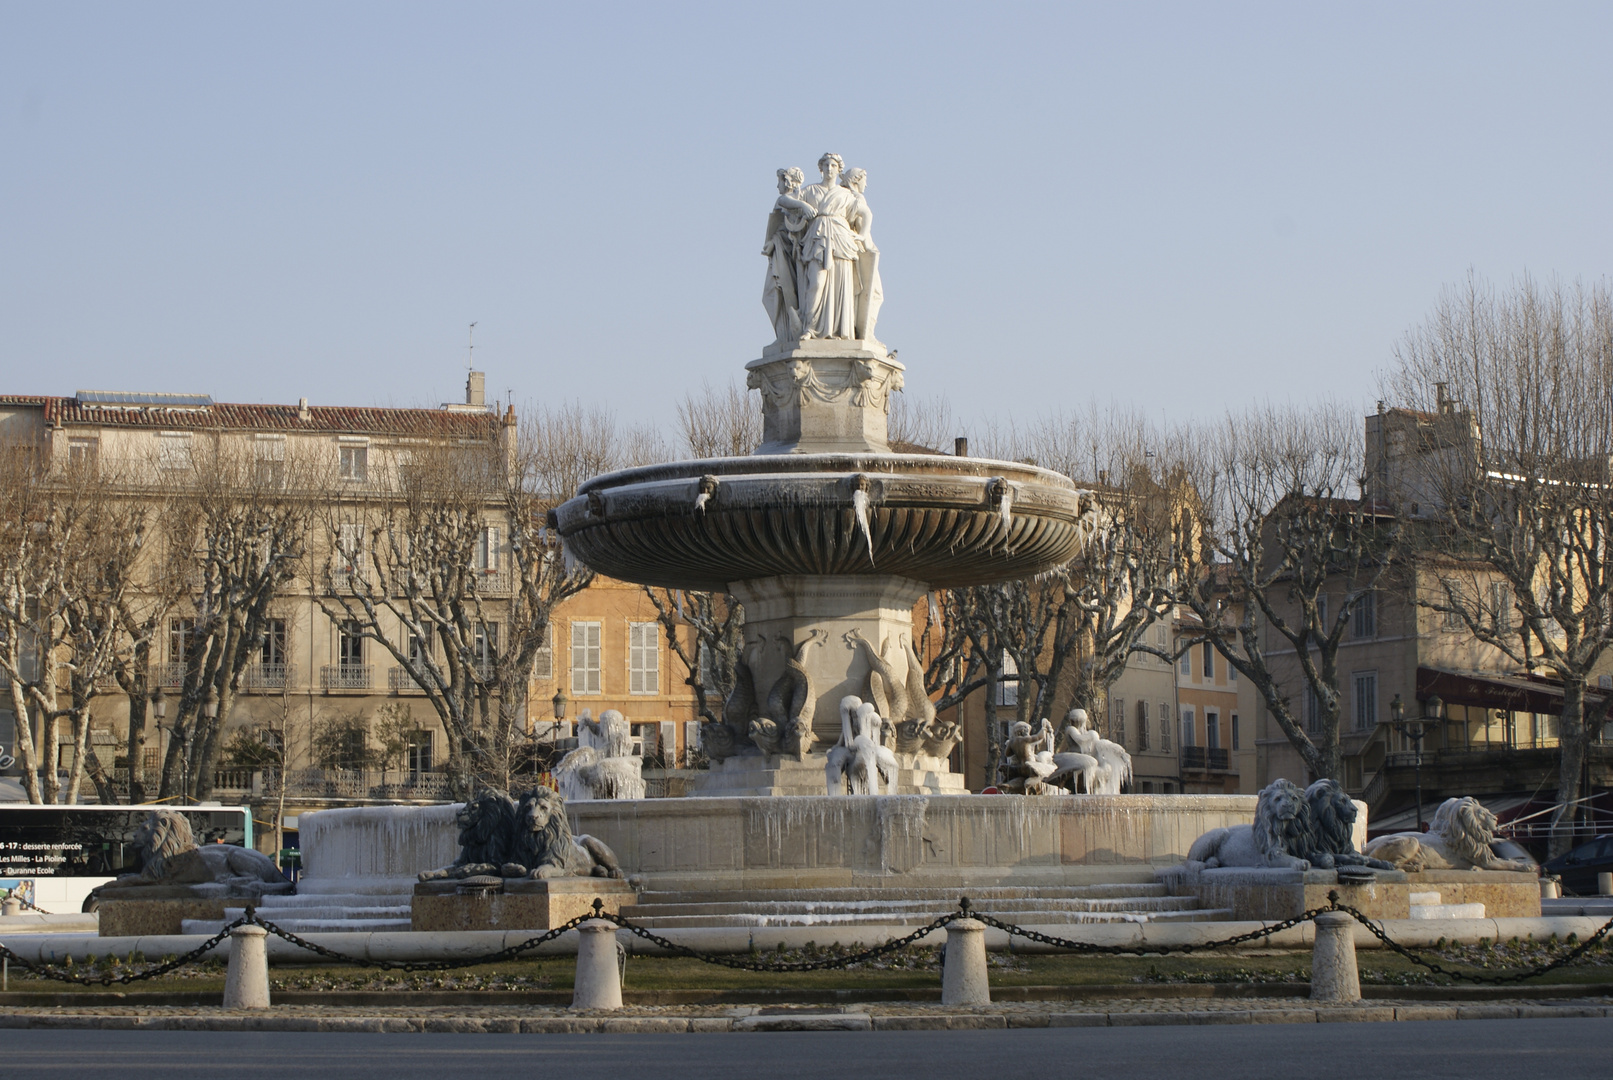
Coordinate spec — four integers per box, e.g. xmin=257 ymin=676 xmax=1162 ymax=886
xmin=1161 ymin=403 xmax=1402 ymax=779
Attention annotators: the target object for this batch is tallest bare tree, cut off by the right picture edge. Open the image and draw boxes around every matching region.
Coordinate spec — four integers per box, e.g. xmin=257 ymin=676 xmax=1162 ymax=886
xmin=1384 ymin=277 xmax=1613 ymax=854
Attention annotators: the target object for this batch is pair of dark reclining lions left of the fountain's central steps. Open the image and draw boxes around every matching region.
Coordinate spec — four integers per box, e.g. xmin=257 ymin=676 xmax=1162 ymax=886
xmin=419 ymin=788 xmax=623 ymax=882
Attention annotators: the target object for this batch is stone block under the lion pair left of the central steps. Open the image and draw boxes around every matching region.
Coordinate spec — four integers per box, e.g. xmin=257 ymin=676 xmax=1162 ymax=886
xmin=410 ymin=877 xmax=636 ymax=932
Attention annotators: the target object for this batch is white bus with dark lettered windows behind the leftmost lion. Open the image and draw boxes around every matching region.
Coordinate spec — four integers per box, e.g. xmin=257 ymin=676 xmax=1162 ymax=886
xmin=0 ymin=803 xmax=252 ymax=914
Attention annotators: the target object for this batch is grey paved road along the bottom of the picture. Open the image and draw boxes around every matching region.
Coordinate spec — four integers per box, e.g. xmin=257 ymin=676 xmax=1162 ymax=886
xmin=9 ymin=1019 xmax=1613 ymax=1080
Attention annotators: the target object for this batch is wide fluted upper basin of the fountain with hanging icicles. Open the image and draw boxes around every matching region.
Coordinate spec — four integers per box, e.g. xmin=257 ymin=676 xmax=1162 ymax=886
xmin=556 ymin=455 xmax=1084 ymax=590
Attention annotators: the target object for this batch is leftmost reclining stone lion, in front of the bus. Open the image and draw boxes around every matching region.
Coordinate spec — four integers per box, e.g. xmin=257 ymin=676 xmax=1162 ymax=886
xmin=84 ymin=806 xmax=295 ymax=911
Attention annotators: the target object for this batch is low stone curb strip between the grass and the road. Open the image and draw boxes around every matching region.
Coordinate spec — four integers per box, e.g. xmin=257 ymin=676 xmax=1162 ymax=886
xmin=0 ymin=1004 xmax=1613 ymax=1035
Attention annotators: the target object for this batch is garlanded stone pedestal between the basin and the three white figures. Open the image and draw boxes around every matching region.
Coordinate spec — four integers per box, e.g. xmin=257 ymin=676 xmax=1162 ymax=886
xmin=745 ymin=340 xmax=903 ymax=455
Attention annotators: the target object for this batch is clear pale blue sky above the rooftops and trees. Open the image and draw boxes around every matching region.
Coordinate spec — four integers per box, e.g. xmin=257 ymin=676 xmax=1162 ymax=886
xmin=0 ymin=2 xmax=1613 ymax=435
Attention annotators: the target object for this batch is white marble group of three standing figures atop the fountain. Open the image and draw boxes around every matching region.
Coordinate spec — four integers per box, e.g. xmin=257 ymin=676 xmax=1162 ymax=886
xmin=761 ymin=153 xmax=884 ymax=343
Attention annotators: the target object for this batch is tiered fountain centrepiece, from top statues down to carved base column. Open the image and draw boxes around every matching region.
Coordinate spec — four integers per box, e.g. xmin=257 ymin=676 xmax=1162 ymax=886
xmin=553 ymin=155 xmax=1082 ymax=795
